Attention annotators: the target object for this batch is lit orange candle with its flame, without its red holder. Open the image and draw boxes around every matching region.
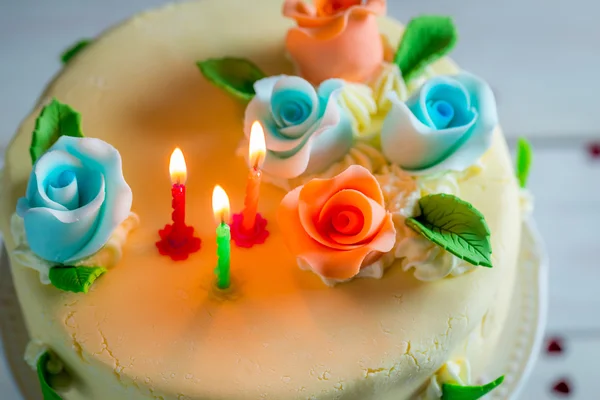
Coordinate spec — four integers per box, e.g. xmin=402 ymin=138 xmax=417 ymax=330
xmin=242 ymin=121 xmax=266 ymax=233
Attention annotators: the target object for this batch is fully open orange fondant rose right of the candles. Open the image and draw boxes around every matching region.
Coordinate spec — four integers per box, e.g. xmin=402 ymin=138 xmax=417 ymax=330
xmin=278 ymin=165 xmax=396 ymax=280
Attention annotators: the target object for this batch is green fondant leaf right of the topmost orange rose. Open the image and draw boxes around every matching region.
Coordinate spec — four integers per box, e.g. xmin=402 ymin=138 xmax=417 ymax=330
xmin=394 ymin=15 xmax=458 ymax=82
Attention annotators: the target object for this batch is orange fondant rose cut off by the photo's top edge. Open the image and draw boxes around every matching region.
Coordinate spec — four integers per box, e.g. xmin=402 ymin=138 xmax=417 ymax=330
xmin=283 ymin=0 xmax=385 ymax=84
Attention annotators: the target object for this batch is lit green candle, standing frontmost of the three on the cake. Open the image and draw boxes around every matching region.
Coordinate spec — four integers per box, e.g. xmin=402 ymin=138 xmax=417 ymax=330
xmin=212 ymin=185 xmax=231 ymax=289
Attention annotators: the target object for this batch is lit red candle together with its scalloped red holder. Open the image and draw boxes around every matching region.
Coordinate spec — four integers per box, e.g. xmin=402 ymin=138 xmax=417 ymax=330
xmin=156 ymin=148 xmax=201 ymax=260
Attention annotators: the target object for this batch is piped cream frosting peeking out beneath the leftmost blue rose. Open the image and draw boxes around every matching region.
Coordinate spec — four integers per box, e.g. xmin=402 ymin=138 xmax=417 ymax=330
xmin=10 ymin=213 xmax=140 ymax=285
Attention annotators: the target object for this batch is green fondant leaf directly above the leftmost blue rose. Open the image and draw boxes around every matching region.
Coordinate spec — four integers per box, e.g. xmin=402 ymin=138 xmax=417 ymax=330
xmin=29 ymin=99 xmax=83 ymax=163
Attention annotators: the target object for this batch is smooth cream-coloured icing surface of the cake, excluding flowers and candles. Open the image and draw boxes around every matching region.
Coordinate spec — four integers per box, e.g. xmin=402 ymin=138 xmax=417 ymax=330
xmin=1 ymin=2 xmax=520 ymax=400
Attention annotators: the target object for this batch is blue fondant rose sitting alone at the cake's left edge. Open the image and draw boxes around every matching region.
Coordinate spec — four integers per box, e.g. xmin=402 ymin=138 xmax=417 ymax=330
xmin=17 ymin=136 xmax=132 ymax=264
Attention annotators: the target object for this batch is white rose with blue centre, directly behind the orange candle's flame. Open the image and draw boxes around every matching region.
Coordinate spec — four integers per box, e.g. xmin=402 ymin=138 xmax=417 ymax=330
xmin=245 ymin=76 xmax=352 ymax=179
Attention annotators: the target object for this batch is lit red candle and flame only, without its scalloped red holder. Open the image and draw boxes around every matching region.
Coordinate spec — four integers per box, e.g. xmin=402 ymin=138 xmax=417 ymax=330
xmin=169 ymin=147 xmax=187 ymax=242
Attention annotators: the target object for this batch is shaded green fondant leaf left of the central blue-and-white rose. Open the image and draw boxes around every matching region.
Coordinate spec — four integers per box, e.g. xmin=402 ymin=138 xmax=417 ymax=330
xmin=198 ymin=57 xmax=266 ymax=101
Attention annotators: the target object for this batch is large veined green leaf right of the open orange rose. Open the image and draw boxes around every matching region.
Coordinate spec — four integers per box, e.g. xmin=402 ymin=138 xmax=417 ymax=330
xmin=406 ymin=194 xmax=492 ymax=268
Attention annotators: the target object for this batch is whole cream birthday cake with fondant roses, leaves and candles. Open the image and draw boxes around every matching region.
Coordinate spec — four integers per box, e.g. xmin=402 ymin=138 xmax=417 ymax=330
xmin=0 ymin=0 xmax=529 ymax=400
